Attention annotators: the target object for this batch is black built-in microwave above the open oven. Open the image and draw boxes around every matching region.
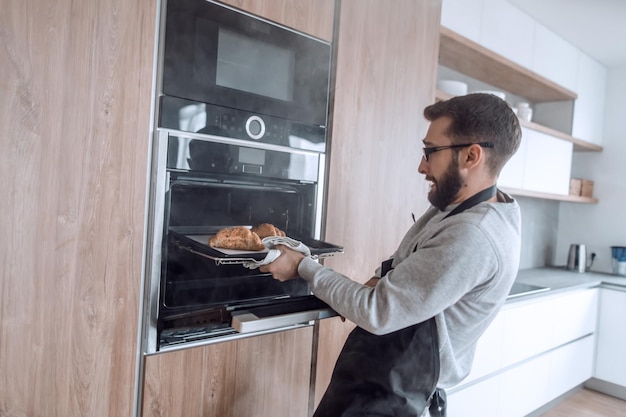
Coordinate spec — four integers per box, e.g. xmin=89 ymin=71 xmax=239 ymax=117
xmin=162 ymin=0 xmax=331 ymax=128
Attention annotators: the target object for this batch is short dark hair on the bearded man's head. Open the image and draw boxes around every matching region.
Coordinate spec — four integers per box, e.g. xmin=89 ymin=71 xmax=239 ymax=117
xmin=424 ymin=93 xmax=522 ymax=176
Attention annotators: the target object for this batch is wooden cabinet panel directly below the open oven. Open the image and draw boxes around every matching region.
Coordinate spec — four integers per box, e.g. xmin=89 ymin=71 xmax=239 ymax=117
xmin=143 ymin=327 xmax=313 ymax=417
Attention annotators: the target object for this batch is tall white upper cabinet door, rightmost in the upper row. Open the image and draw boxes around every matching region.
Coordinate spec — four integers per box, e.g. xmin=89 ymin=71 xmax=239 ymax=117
xmin=572 ymin=53 xmax=607 ymax=145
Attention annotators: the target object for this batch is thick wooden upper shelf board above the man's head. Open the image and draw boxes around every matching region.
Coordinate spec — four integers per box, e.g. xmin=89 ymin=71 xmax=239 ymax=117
xmin=439 ymin=26 xmax=577 ymax=103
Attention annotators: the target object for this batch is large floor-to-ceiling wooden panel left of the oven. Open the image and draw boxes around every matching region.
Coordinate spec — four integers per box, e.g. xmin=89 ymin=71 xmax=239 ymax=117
xmin=0 ymin=0 xmax=156 ymax=417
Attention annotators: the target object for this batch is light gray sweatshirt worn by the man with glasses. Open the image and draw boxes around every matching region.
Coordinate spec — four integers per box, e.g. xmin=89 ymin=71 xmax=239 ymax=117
xmin=298 ymin=192 xmax=521 ymax=388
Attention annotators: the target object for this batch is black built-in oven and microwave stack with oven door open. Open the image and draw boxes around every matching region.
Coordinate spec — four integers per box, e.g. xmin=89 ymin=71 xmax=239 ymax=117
xmin=142 ymin=0 xmax=343 ymax=353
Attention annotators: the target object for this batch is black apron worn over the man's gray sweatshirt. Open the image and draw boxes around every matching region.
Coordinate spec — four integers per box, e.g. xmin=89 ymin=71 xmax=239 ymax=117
xmin=313 ymin=185 xmax=496 ymax=417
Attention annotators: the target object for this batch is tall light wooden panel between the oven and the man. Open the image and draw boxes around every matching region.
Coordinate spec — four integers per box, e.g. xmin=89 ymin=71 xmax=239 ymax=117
xmin=316 ymin=0 xmax=441 ymax=403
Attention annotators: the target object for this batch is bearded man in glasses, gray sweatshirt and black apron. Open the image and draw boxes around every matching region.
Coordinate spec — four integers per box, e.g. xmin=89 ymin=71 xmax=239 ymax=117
xmin=261 ymin=94 xmax=521 ymax=417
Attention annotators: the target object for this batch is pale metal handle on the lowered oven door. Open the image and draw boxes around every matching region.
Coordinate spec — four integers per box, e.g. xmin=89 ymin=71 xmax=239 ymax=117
xmin=231 ymin=307 xmax=337 ymax=333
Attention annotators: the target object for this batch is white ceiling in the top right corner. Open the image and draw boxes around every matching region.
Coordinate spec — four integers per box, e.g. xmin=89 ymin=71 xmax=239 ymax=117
xmin=509 ymin=0 xmax=626 ymax=68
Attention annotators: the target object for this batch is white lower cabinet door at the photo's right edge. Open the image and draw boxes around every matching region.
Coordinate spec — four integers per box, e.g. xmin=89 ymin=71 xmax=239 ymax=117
xmin=594 ymin=288 xmax=626 ymax=388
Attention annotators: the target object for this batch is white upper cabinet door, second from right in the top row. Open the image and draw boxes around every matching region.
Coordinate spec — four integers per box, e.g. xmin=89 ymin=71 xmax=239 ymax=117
xmin=531 ymin=23 xmax=579 ymax=91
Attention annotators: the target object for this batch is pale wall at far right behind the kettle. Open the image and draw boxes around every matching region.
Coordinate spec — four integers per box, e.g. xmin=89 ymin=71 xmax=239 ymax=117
xmin=553 ymin=68 xmax=626 ymax=272
